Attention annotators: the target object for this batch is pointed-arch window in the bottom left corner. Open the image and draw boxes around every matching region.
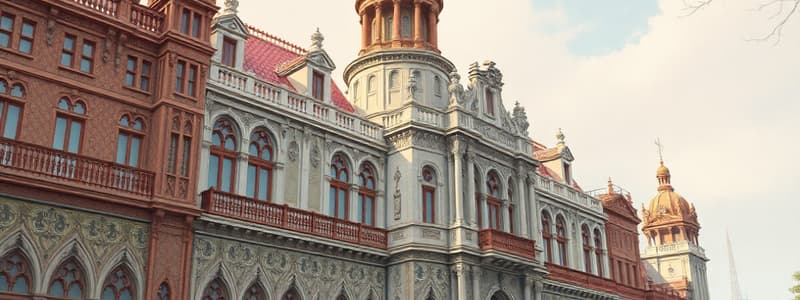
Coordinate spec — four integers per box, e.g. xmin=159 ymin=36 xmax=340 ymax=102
xmin=0 ymin=250 xmax=33 ymax=294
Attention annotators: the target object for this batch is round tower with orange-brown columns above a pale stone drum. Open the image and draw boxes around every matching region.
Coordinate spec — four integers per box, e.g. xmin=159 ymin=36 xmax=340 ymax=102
xmin=344 ymin=0 xmax=455 ymax=116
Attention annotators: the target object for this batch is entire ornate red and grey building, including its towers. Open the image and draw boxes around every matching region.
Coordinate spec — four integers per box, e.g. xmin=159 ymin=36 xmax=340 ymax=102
xmin=0 ymin=0 xmax=707 ymax=300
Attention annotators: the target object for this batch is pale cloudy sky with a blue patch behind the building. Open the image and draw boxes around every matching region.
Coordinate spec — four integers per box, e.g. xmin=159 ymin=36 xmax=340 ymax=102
xmin=225 ymin=0 xmax=800 ymax=300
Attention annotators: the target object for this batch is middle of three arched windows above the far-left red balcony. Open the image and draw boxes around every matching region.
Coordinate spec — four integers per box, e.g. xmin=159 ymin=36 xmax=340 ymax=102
xmin=53 ymin=97 xmax=86 ymax=153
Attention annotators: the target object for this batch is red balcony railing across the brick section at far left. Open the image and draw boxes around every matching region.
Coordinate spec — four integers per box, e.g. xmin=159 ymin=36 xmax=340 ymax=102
xmin=0 ymin=138 xmax=155 ymax=197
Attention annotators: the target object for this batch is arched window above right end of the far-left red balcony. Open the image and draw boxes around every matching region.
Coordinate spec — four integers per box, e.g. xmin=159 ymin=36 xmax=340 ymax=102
xmin=116 ymin=114 xmax=144 ymax=168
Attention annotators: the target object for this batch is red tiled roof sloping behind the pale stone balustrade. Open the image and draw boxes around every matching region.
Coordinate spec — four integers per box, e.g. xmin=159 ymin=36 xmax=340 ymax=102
xmin=244 ymin=26 xmax=355 ymax=113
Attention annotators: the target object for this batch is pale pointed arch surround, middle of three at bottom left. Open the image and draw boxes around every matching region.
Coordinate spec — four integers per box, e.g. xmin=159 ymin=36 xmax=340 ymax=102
xmin=39 ymin=238 xmax=98 ymax=298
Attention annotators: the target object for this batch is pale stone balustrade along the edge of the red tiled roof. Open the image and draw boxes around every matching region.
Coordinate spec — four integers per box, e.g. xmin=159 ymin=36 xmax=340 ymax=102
xmin=210 ymin=63 xmax=386 ymax=144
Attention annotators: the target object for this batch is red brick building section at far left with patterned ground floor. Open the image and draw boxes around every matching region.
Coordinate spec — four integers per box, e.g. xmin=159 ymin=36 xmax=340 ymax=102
xmin=0 ymin=0 xmax=217 ymax=299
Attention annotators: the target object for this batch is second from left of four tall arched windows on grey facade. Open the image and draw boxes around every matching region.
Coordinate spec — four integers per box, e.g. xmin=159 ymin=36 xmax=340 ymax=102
xmin=247 ymin=129 xmax=275 ymax=201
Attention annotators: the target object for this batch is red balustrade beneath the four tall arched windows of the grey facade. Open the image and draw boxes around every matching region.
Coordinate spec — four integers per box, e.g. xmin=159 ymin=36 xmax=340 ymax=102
xmin=202 ymin=189 xmax=387 ymax=249
